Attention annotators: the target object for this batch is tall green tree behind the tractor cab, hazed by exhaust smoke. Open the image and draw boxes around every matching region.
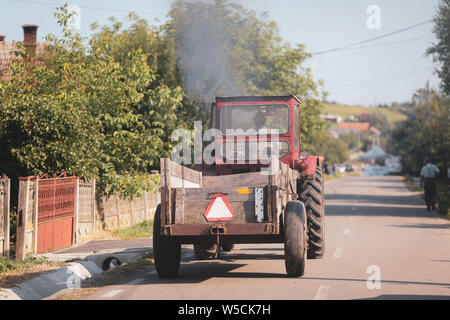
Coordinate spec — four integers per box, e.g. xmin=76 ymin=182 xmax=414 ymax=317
xmin=163 ymin=0 xmax=324 ymax=148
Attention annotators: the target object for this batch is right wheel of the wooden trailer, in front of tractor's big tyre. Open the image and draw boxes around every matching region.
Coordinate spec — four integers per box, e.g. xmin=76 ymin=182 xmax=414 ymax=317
xmin=284 ymin=200 xmax=306 ymax=277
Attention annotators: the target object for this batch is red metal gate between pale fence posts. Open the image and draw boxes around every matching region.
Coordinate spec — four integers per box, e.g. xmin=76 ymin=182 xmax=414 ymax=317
xmin=37 ymin=177 xmax=77 ymax=253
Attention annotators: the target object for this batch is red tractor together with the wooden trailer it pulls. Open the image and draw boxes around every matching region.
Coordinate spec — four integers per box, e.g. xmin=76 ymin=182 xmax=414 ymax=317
xmin=153 ymin=96 xmax=325 ymax=277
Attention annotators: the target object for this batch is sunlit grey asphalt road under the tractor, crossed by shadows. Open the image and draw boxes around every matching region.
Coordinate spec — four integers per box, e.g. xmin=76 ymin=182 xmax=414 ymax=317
xmin=81 ymin=177 xmax=450 ymax=300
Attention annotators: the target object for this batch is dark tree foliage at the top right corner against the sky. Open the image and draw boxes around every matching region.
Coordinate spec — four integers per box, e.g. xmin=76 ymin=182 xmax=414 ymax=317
xmin=426 ymin=0 xmax=450 ymax=95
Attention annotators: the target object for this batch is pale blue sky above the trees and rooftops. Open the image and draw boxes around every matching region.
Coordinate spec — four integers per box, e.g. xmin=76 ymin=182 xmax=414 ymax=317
xmin=0 ymin=0 xmax=439 ymax=106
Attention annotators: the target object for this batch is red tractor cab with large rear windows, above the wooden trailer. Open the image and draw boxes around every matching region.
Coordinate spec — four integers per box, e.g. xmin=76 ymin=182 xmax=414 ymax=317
xmin=211 ymin=95 xmax=314 ymax=174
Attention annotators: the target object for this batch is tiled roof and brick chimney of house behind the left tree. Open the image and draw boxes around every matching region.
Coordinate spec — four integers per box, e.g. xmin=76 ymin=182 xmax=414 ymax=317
xmin=0 ymin=24 xmax=46 ymax=81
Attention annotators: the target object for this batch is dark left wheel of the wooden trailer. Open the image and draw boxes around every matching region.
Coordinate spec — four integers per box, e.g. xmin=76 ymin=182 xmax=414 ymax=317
xmin=153 ymin=204 xmax=181 ymax=278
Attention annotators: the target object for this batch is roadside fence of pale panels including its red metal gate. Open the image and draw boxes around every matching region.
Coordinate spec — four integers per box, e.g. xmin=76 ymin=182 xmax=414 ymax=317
xmin=14 ymin=176 xmax=161 ymax=259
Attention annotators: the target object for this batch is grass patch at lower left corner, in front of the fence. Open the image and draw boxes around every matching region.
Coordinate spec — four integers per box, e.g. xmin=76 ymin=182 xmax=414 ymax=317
xmin=0 ymin=257 xmax=66 ymax=288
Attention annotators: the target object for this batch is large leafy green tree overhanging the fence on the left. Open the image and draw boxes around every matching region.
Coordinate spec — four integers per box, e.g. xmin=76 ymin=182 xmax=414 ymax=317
xmin=0 ymin=6 xmax=182 ymax=196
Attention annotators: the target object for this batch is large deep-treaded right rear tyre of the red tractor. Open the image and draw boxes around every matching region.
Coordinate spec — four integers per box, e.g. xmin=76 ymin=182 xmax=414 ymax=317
xmin=298 ymin=166 xmax=325 ymax=259
